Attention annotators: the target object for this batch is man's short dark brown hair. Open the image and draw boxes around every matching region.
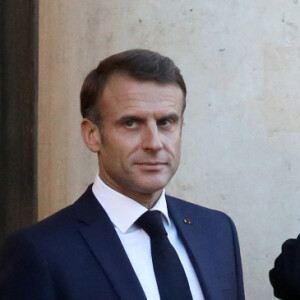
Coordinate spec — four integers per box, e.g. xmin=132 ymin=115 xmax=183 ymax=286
xmin=80 ymin=49 xmax=186 ymax=125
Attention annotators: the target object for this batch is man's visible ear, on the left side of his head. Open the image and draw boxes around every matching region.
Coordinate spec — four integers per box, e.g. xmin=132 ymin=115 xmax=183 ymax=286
xmin=81 ymin=119 xmax=101 ymax=152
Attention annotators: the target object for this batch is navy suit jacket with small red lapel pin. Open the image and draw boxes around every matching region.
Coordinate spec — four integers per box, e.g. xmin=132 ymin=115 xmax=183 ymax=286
xmin=0 ymin=186 xmax=244 ymax=300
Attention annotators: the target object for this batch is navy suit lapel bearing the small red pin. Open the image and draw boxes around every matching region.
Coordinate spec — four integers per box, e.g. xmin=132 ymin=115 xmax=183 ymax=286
xmin=167 ymin=196 xmax=223 ymax=300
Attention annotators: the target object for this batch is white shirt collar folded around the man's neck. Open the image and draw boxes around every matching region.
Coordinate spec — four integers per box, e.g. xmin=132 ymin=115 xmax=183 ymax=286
xmin=92 ymin=175 xmax=170 ymax=233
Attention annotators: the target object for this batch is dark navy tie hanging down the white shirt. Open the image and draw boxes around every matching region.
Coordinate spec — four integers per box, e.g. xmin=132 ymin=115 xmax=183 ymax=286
xmin=136 ymin=211 xmax=193 ymax=300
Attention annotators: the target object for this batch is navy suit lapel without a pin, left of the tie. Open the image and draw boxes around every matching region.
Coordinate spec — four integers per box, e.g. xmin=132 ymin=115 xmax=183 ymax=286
xmin=74 ymin=187 xmax=146 ymax=299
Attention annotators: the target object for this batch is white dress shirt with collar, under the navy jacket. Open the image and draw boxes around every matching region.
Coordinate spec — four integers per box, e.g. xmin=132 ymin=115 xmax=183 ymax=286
xmin=92 ymin=175 xmax=204 ymax=300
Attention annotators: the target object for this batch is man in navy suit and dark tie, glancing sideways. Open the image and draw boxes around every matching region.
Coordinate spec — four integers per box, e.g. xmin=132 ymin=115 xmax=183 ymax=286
xmin=0 ymin=49 xmax=244 ymax=300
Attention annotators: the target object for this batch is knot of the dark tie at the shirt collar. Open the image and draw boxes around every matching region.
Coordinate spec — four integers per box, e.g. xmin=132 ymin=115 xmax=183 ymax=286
xmin=135 ymin=210 xmax=167 ymax=238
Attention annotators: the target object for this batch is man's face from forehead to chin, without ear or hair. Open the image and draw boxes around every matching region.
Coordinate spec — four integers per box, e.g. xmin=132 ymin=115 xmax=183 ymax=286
xmin=99 ymin=75 xmax=183 ymax=204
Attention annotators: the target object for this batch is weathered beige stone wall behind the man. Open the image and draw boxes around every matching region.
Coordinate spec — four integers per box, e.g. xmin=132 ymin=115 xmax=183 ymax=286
xmin=38 ymin=0 xmax=300 ymax=300
